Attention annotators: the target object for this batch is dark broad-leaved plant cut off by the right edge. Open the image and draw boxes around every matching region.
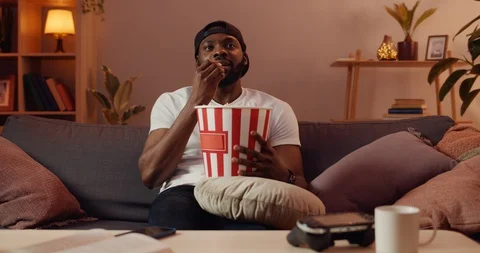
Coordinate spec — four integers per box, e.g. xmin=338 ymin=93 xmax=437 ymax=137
xmin=428 ymin=0 xmax=480 ymax=116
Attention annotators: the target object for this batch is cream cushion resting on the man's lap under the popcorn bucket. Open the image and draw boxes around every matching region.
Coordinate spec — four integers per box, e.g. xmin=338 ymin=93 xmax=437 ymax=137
xmin=194 ymin=176 xmax=325 ymax=229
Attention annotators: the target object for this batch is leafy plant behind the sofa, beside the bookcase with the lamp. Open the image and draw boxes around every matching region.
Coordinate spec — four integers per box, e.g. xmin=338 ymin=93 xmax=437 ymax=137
xmin=88 ymin=65 xmax=145 ymax=125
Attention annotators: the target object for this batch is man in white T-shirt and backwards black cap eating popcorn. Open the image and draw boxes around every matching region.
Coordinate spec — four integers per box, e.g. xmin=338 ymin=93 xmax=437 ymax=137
xmin=139 ymin=21 xmax=307 ymax=229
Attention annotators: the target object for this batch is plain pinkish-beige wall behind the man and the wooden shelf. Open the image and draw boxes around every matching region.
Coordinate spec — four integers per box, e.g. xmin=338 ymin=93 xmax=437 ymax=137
xmin=99 ymin=0 xmax=480 ymax=124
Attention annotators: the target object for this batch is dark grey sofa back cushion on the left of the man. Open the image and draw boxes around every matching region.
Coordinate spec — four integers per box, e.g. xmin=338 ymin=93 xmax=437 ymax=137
xmin=2 ymin=116 xmax=158 ymax=222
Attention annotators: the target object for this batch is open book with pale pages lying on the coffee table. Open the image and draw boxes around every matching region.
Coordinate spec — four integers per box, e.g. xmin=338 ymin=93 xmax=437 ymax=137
xmin=0 ymin=229 xmax=173 ymax=253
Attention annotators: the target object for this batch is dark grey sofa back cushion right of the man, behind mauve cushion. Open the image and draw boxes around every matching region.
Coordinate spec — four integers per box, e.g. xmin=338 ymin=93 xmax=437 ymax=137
xmin=299 ymin=116 xmax=455 ymax=182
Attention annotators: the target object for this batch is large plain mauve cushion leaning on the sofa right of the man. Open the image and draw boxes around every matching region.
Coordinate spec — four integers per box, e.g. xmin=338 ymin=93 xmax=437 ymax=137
xmin=309 ymin=131 xmax=456 ymax=213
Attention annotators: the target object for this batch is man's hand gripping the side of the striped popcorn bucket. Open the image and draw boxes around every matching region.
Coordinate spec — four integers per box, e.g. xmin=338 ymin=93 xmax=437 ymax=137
xmin=232 ymin=131 xmax=289 ymax=182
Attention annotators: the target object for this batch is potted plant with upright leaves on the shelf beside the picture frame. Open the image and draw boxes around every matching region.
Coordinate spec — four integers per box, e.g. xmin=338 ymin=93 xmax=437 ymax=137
xmin=385 ymin=1 xmax=437 ymax=61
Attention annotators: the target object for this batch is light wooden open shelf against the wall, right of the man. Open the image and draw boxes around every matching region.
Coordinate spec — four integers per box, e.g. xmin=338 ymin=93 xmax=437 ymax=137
xmin=330 ymin=49 xmax=471 ymax=124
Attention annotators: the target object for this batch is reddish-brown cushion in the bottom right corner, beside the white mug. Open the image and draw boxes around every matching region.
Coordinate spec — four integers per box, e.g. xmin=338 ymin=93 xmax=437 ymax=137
xmin=395 ymin=156 xmax=480 ymax=235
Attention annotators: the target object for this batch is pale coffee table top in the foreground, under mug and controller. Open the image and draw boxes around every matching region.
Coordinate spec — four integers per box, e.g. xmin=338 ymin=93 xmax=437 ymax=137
xmin=0 ymin=230 xmax=480 ymax=253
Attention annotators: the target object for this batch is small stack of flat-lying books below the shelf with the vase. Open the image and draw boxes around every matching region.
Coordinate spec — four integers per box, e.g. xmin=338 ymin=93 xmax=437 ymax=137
xmin=383 ymin=98 xmax=428 ymax=119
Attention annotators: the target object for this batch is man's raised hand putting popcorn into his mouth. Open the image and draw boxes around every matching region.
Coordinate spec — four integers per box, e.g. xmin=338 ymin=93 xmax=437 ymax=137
xmin=190 ymin=59 xmax=225 ymax=105
